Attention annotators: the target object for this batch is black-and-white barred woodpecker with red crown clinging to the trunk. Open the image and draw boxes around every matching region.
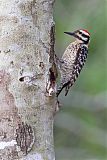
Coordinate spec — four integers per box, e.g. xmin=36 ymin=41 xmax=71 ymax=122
xmin=56 ymin=29 xmax=90 ymax=97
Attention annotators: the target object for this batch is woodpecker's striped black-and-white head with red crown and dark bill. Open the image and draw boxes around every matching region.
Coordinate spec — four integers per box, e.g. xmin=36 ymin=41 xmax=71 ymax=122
xmin=64 ymin=29 xmax=90 ymax=45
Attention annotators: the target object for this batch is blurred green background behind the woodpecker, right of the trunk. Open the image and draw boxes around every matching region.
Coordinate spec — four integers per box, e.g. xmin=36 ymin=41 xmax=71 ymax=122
xmin=54 ymin=0 xmax=107 ymax=160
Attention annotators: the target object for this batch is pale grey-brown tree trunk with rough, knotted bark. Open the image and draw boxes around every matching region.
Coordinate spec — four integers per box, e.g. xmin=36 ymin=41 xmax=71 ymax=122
xmin=0 ymin=0 xmax=56 ymax=160
